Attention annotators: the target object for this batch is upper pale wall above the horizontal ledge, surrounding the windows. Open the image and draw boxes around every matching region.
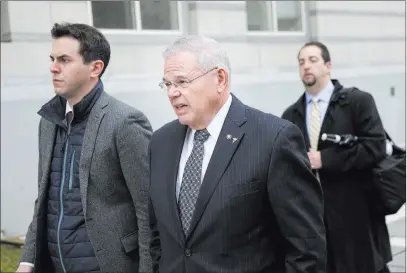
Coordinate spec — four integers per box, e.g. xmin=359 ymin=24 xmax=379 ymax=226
xmin=1 ymin=1 xmax=405 ymax=79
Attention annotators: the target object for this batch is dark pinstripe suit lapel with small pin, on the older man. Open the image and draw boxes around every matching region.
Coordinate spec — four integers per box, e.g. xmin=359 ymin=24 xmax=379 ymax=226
xmin=189 ymin=96 xmax=246 ymax=237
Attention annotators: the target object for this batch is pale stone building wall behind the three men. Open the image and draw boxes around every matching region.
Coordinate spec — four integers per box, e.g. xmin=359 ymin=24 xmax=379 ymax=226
xmin=1 ymin=1 xmax=406 ymax=235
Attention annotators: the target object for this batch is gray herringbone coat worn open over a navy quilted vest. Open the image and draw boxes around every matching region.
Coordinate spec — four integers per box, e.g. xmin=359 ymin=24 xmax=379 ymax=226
xmin=21 ymin=92 xmax=152 ymax=273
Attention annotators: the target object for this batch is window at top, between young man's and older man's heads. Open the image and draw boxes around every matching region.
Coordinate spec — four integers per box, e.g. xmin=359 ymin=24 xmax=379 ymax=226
xmin=90 ymin=0 xmax=181 ymax=31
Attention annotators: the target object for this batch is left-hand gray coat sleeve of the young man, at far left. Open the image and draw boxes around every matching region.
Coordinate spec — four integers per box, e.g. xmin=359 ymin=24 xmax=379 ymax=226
xmin=20 ymin=119 xmax=42 ymax=264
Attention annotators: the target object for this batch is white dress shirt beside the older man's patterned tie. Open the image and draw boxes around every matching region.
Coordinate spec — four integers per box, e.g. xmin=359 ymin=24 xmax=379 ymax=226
xmin=176 ymin=95 xmax=232 ymax=200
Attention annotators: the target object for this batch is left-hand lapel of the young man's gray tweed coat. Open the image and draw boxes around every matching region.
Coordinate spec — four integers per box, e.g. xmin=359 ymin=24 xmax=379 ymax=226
xmin=38 ymin=120 xmax=57 ymax=203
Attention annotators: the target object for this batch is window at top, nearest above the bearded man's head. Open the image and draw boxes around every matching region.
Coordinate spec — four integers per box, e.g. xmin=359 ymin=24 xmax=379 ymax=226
xmin=246 ymin=1 xmax=304 ymax=33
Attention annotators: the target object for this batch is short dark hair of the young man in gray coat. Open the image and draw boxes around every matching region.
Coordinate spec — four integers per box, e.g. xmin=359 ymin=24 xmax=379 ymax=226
xmin=51 ymin=23 xmax=110 ymax=77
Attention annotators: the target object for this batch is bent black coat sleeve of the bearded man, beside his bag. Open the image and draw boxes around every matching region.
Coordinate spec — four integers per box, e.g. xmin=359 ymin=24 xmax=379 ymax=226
xmin=321 ymin=90 xmax=386 ymax=173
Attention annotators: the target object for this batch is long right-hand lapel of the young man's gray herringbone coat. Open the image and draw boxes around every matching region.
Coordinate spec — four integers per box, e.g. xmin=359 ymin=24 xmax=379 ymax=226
xmin=79 ymin=92 xmax=109 ymax=217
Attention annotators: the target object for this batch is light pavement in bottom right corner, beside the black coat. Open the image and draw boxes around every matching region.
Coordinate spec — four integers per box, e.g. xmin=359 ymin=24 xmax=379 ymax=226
xmin=386 ymin=206 xmax=406 ymax=273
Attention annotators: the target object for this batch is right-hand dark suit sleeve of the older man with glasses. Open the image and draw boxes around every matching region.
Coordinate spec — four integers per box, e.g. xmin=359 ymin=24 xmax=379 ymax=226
xmin=268 ymin=123 xmax=326 ymax=273
